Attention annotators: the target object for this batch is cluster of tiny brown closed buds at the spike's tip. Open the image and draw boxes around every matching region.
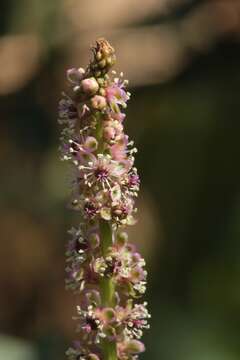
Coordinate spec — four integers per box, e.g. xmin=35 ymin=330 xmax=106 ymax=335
xmin=90 ymin=39 xmax=116 ymax=77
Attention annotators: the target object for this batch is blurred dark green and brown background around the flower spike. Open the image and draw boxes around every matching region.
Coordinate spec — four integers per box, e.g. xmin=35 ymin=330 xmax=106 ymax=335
xmin=0 ymin=0 xmax=240 ymax=360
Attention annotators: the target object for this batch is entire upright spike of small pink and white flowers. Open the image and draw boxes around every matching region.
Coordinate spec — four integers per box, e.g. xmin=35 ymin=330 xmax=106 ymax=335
xmin=59 ymin=39 xmax=150 ymax=360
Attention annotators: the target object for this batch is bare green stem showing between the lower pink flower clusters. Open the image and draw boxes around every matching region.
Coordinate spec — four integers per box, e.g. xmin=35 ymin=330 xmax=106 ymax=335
xmin=99 ymin=220 xmax=117 ymax=360
